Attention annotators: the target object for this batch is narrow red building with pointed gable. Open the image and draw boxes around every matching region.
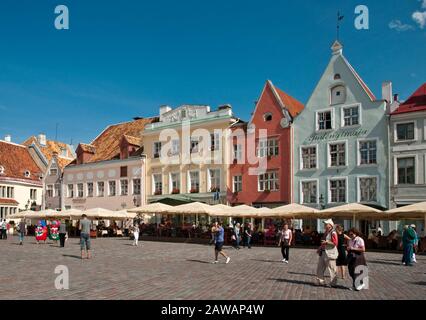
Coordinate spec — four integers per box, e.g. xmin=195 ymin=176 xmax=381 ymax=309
xmin=228 ymin=81 xmax=304 ymax=207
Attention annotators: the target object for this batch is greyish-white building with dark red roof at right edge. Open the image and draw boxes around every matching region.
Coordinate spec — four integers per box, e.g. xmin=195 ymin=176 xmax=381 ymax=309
xmin=390 ymin=83 xmax=426 ymax=212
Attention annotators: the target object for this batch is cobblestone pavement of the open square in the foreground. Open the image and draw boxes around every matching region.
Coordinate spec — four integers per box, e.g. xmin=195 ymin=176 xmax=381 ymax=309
xmin=0 ymin=237 xmax=426 ymax=300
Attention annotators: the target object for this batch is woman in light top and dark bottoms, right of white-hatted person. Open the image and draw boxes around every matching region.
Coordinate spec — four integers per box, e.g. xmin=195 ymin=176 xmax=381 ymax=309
xmin=348 ymin=228 xmax=367 ymax=291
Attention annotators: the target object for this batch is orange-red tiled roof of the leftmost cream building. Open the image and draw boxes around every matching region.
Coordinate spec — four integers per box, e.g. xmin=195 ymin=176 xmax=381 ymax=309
xmin=0 ymin=141 xmax=42 ymax=182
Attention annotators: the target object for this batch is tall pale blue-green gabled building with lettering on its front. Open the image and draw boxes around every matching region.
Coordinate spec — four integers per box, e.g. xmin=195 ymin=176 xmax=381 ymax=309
xmin=293 ymin=41 xmax=392 ymax=230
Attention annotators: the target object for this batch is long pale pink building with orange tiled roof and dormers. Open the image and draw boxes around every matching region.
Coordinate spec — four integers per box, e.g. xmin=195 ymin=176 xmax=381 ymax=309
xmin=62 ymin=118 xmax=153 ymax=211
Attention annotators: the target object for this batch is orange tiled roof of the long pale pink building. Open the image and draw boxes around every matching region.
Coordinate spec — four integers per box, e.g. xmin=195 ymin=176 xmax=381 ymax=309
xmin=74 ymin=117 xmax=158 ymax=163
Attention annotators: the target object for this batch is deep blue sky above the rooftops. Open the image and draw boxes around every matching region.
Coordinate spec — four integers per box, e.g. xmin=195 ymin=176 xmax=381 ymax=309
xmin=0 ymin=0 xmax=426 ymax=145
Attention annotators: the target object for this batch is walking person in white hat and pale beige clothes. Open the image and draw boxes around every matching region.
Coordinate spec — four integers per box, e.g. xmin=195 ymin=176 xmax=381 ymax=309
xmin=317 ymin=219 xmax=339 ymax=287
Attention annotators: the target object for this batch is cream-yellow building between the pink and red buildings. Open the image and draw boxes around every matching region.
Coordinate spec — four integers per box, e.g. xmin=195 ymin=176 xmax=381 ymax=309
xmin=142 ymin=105 xmax=237 ymax=204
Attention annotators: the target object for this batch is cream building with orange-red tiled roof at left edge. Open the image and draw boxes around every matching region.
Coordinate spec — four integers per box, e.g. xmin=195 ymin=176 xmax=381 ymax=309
xmin=0 ymin=136 xmax=43 ymax=219
